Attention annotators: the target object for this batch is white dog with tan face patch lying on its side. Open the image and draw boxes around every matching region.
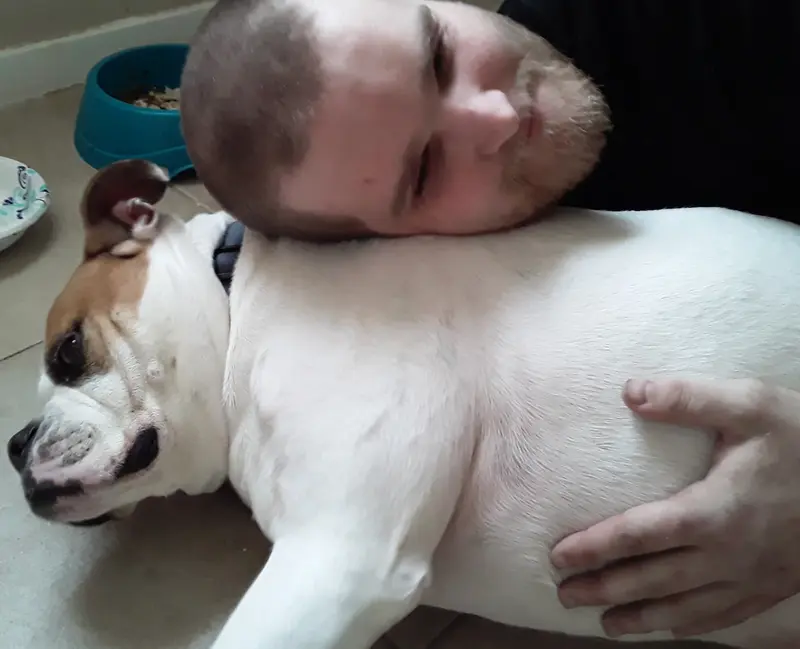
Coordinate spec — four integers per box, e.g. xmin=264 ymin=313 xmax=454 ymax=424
xmin=9 ymin=162 xmax=800 ymax=649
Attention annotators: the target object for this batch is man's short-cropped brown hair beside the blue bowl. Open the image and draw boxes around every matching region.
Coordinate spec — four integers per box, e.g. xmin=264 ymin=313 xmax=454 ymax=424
xmin=181 ymin=0 xmax=368 ymax=240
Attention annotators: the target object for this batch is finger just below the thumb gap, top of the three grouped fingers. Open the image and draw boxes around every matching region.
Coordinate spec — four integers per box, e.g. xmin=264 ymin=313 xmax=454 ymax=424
xmin=550 ymin=494 xmax=707 ymax=572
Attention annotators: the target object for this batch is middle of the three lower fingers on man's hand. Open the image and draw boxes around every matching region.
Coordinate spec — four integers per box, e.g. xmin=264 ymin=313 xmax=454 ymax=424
xmin=558 ymin=548 xmax=718 ymax=608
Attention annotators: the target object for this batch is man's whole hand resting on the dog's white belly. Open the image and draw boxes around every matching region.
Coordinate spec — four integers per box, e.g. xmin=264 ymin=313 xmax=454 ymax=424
xmin=552 ymin=380 xmax=800 ymax=637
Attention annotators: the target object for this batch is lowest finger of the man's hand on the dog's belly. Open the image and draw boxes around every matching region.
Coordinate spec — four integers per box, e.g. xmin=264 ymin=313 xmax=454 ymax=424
xmin=603 ymin=583 xmax=738 ymax=638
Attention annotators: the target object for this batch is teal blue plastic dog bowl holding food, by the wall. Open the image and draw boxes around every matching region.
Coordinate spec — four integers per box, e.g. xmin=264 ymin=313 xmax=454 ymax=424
xmin=75 ymin=44 xmax=192 ymax=178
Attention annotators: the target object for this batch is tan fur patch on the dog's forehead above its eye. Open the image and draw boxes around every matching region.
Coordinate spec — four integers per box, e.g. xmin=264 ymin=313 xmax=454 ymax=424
xmin=45 ymin=253 xmax=148 ymax=348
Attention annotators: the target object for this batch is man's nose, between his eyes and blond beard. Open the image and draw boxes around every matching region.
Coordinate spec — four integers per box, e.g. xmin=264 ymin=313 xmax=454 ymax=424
xmin=447 ymin=90 xmax=520 ymax=157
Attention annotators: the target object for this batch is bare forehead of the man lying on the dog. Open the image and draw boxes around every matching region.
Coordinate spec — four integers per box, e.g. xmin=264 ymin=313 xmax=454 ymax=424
xmin=281 ymin=0 xmax=429 ymax=218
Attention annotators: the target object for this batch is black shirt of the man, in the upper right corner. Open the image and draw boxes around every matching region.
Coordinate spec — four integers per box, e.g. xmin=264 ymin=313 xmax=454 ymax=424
xmin=500 ymin=0 xmax=800 ymax=222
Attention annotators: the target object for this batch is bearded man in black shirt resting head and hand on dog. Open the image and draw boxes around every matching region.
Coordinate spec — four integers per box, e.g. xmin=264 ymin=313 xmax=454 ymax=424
xmin=182 ymin=0 xmax=800 ymax=635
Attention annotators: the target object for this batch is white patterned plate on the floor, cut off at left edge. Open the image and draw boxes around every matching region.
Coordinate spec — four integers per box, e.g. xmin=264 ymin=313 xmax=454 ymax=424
xmin=0 ymin=156 xmax=50 ymax=251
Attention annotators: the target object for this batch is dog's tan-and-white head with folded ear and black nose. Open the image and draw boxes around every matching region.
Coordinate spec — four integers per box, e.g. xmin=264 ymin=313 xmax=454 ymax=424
xmin=8 ymin=161 xmax=228 ymax=524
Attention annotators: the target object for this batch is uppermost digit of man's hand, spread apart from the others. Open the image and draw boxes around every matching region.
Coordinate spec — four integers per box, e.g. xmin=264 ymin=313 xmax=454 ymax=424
xmin=623 ymin=379 xmax=777 ymax=435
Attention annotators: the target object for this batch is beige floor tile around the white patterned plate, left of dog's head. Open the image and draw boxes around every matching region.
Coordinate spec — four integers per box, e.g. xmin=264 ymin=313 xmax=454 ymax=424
xmin=0 ymin=87 xmax=209 ymax=358
